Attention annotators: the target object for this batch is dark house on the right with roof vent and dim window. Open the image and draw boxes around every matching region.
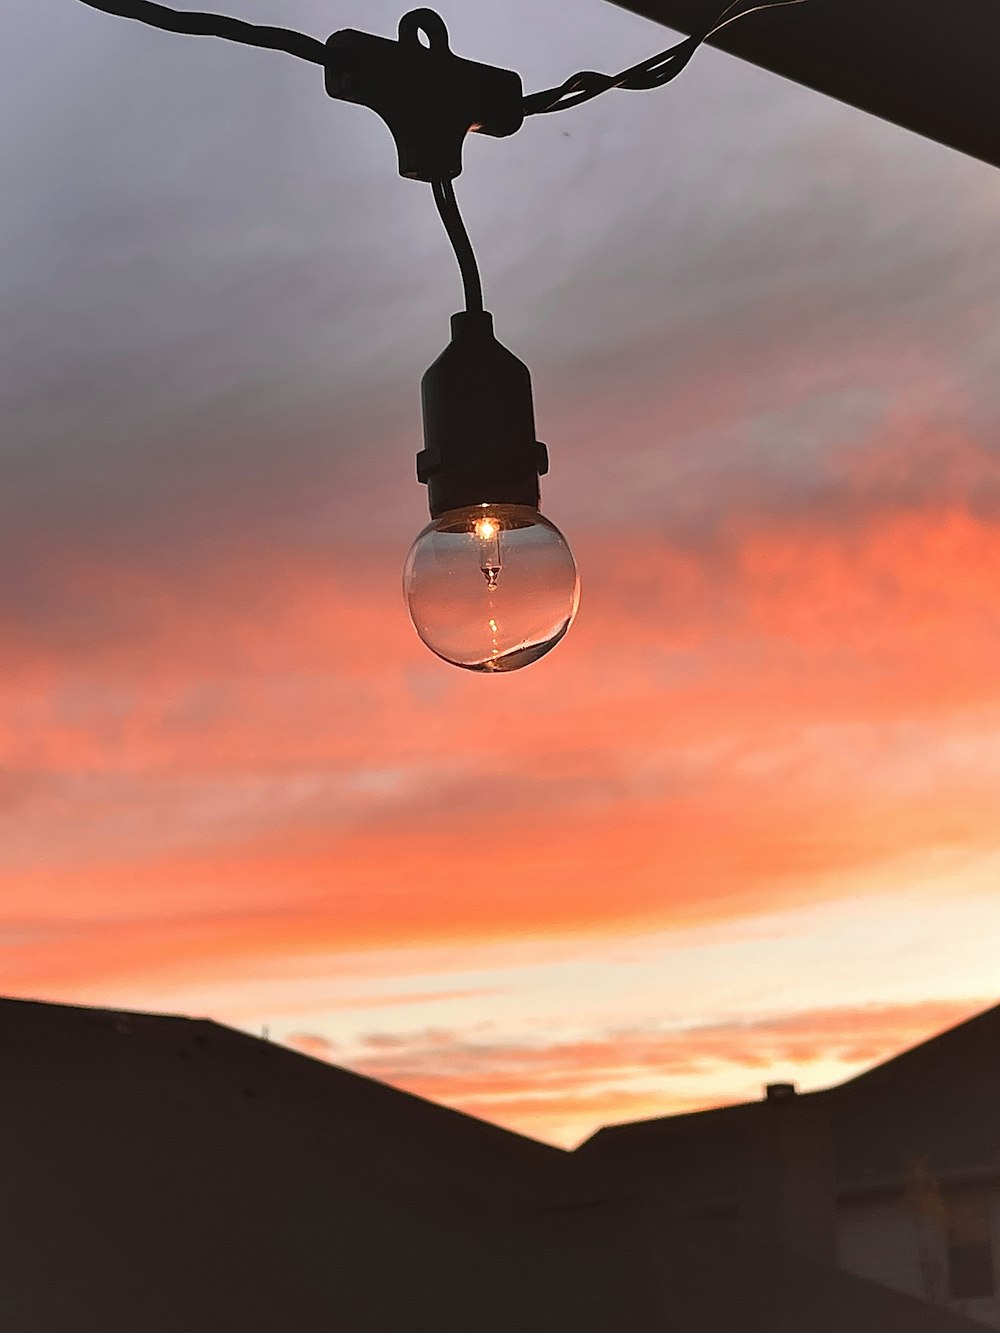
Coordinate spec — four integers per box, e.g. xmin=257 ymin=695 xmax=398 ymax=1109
xmin=577 ymin=1006 xmax=1000 ymax=1328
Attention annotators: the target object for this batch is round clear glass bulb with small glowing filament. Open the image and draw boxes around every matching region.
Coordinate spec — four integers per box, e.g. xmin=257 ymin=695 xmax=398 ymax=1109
xmin=403 ymin=504 xmax=580 ymax=672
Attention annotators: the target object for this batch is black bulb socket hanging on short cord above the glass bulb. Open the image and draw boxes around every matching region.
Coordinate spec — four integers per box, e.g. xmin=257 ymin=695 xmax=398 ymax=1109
xmin=417 ymin=311 xmax=548 ymax=519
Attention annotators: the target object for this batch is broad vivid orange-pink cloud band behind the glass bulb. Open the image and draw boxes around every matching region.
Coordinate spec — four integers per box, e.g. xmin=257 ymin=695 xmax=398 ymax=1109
xmin=0 ymin=410 xmax=1000 ymax=994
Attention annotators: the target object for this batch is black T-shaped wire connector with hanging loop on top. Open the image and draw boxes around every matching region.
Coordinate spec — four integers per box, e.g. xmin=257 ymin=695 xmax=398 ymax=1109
xmin=327 ymin=9 xmax=524 ymax=183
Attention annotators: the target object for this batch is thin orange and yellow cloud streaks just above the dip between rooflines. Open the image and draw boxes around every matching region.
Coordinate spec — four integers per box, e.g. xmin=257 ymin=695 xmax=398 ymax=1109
xmin=329 ymin=1000 xmax=985 ymax=1142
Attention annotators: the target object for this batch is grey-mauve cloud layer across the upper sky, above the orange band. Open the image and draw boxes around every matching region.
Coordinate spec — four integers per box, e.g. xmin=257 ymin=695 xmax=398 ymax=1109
xmin=0 ymin=0 xmax=1000 ymax=594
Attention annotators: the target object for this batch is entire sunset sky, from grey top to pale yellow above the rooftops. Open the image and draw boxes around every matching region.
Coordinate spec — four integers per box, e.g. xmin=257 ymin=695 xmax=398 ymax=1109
xmin=0 ymin=0 xmax=1000 ymax=1145
